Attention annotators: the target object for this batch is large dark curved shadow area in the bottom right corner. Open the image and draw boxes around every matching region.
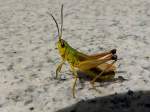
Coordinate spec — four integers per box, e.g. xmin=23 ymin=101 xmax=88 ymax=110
xmin=57 ymin=90 xmax=150 ymax=112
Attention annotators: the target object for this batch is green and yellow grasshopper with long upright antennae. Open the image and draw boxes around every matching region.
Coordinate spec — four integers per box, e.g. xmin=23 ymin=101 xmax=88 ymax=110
xmin=50 ymin=5 xmax=117 ymax=97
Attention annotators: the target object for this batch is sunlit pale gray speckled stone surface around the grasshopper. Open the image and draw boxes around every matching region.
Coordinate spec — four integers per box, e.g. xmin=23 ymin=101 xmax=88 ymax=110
xmin=0 ymin=0 xmax=150 ymax=112
